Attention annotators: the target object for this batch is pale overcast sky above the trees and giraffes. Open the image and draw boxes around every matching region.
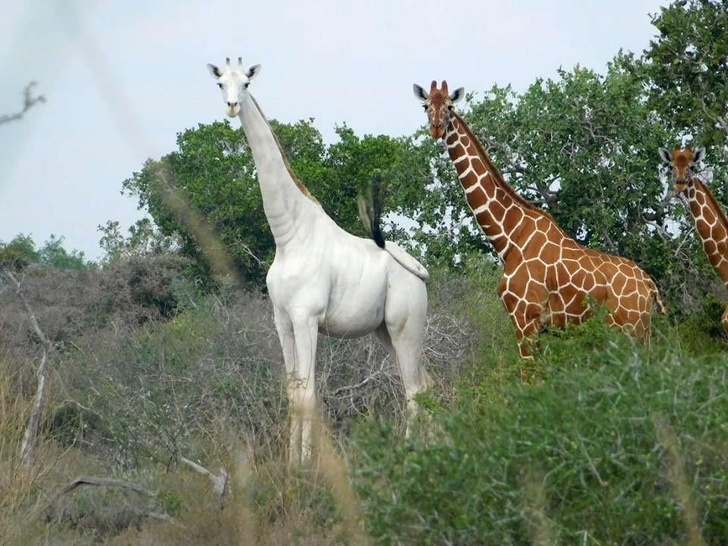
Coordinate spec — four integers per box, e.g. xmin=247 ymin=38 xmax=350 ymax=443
xmin=0 ymin=0 xmax=667 ymax=259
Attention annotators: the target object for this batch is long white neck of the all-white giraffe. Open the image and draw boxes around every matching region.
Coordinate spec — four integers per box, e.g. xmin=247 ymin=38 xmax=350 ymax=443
xmin=239 ymin=94 xmax=319 ymax=247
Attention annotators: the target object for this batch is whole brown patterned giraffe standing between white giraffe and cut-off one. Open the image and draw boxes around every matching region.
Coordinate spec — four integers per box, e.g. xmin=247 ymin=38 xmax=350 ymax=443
xmin=414 ymin=81 xmax=664 ymax=358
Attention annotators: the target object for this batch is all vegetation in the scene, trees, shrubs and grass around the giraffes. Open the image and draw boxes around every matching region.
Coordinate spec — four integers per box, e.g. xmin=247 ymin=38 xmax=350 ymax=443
xmin=0 ymin=0 xmax=728 ymax=545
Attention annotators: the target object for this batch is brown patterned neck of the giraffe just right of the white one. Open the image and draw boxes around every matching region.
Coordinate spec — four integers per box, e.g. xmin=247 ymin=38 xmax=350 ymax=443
xmin=445 ymin=112 xmax=545 ymax=260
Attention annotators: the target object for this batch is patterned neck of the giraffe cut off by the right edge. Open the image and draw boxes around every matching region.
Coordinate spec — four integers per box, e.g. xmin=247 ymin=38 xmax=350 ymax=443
xmin=686 ymin=178 xmax=728 ymax=287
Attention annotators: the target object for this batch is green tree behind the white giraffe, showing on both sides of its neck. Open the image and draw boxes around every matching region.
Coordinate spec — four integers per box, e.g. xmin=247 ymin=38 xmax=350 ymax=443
xmin=121 ymin=119 xmax=426 ymax=286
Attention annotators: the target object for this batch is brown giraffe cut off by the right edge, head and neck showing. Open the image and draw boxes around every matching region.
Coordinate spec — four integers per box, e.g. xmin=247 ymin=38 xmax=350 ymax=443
xmin=660 ymin=147 xmax=728 ymax=332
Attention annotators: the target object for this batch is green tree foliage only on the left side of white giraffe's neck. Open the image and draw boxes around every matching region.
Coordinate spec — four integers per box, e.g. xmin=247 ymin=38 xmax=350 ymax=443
xmin=123 ymin=122 xmax=272 ymax=284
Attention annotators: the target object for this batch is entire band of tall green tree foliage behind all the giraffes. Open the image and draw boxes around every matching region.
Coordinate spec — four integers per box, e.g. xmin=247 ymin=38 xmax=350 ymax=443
xmin=114 ymin=0 xmax=728 ymax=314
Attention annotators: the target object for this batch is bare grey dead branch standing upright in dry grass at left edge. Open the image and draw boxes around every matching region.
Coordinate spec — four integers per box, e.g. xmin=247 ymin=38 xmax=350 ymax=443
xmin=5 ymin=271 xmax=52 ymax=468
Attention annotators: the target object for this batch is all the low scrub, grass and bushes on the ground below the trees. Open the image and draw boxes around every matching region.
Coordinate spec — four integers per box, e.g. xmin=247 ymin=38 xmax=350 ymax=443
xmin=0 ymin=262 xmax=728 ymax=545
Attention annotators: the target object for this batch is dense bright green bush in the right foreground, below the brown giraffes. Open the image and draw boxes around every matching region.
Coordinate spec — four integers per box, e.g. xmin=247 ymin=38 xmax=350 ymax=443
xmin=354 ymin=330 xmax=728 ymax=544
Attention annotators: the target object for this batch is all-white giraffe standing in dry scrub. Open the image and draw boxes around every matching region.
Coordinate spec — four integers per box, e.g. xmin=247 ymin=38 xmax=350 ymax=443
xmin=207 ymin=58 xmax=430 ymax=462
